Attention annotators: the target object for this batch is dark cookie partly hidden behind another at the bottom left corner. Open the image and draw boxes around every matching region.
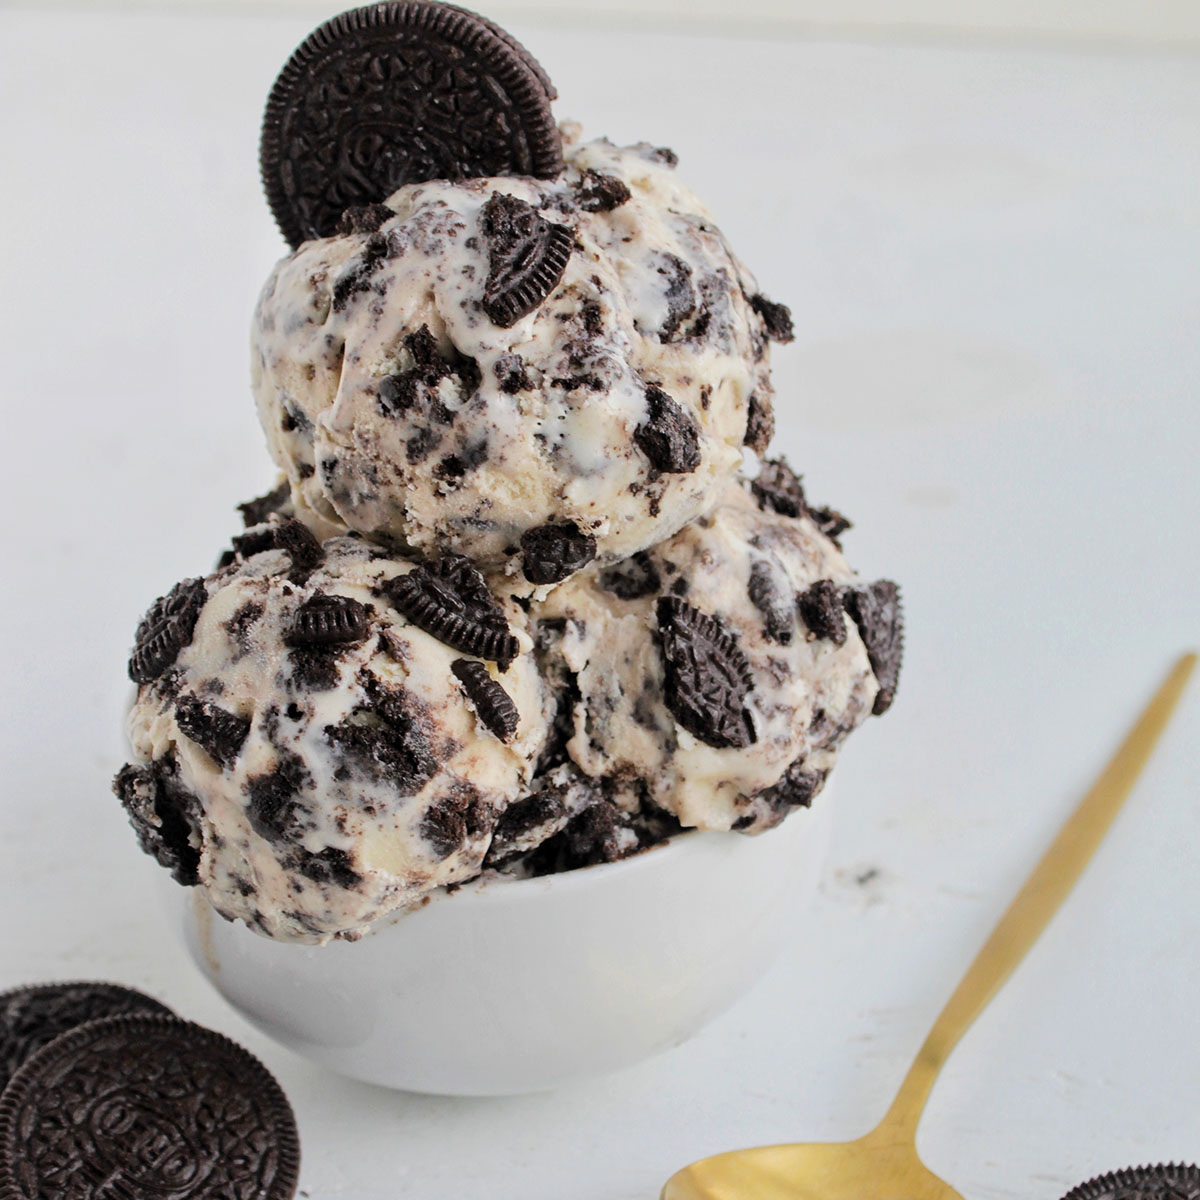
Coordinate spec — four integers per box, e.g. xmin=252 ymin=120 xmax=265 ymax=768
xmin=0 ymin=983 xmax=170 ymax=1092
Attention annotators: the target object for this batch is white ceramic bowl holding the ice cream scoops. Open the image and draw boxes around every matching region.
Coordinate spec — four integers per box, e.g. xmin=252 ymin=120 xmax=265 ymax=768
xmin=173 ymin=793 xmax=830 ymax=1096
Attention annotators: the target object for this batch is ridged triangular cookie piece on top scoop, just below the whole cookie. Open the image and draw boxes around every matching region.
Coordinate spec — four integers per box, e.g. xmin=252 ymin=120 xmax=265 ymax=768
xmin=482 ymin=192 xmax=575 ymax=329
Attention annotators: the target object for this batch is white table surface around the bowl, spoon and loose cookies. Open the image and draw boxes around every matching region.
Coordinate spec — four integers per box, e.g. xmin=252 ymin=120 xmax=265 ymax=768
xmin=0 ymin=10 xmax=1200 ymax=1200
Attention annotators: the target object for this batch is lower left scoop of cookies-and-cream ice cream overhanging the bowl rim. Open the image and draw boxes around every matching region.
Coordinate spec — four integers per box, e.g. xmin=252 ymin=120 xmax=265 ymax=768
xmin=118 ymin=517 xmax=552 ymax=941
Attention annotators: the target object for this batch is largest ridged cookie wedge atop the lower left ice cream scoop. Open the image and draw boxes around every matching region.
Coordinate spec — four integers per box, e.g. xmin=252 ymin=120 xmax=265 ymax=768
xmin=382 ymin=554 xmax=521 ymax=671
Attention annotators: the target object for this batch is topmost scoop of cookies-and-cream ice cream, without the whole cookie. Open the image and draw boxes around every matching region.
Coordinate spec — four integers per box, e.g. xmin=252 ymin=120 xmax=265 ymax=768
xmin=252 ymin=128 xmax=791 ymax=583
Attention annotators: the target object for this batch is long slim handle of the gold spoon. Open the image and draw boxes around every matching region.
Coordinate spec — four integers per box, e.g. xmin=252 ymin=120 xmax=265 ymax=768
xmin=878 ymin=654 xmax=1196 ymax=1140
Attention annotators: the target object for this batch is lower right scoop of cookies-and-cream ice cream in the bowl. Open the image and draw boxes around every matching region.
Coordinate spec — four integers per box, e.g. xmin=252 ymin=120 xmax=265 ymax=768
xmin=530 ymin=464 xmax=881 ymax=832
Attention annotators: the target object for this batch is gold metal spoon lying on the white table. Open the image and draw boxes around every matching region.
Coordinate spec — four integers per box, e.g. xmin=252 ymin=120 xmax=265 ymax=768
xmin=662 ymin=654 xmax=1196 ymax=1200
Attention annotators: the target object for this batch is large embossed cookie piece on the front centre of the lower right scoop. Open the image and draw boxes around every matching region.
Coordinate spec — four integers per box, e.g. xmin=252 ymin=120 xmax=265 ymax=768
xmin=655 ymin=596 xmax=757 ymax=750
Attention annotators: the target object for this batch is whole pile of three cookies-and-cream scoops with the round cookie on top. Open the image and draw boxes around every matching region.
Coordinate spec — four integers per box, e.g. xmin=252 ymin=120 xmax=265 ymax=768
xmin=116 ymin=4 xmax=901 ymax=942
